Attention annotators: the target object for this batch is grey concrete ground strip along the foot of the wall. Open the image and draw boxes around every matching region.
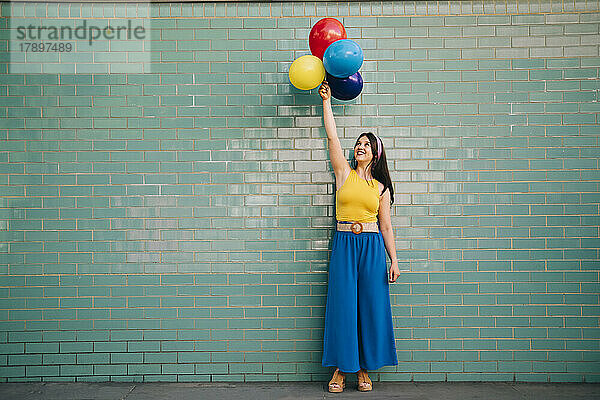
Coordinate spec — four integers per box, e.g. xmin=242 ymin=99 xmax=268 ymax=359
xmin=0 ymin=382 xmax=600 ymax=400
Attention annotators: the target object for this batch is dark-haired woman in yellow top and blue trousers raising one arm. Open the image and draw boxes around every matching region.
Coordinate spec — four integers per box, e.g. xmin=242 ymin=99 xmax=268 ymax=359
xmin=319 ymin=82 xmax=400 ymax=392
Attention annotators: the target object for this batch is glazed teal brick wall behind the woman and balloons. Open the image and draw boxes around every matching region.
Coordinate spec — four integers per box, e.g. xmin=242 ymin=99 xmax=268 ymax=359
xmin=0 ymin=0 xmax=600 ymax=382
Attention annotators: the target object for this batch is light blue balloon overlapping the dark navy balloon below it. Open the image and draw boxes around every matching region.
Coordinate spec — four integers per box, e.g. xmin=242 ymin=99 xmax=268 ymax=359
xmin=323 ymin=39 xmax=363 ymax=78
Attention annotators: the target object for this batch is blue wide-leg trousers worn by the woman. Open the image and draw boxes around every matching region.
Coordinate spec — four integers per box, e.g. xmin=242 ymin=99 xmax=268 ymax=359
xmin=322 ymin=231 xmax=398 ymax=372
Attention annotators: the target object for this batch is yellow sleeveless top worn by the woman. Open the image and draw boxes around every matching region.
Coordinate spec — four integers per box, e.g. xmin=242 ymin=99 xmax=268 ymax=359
xmin=335 ymin=169 xmax=379 ymax=222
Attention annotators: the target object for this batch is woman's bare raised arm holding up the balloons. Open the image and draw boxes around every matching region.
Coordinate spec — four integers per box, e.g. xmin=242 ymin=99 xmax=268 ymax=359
xmin=319 ymin=82 xmax=350 ymax=189
